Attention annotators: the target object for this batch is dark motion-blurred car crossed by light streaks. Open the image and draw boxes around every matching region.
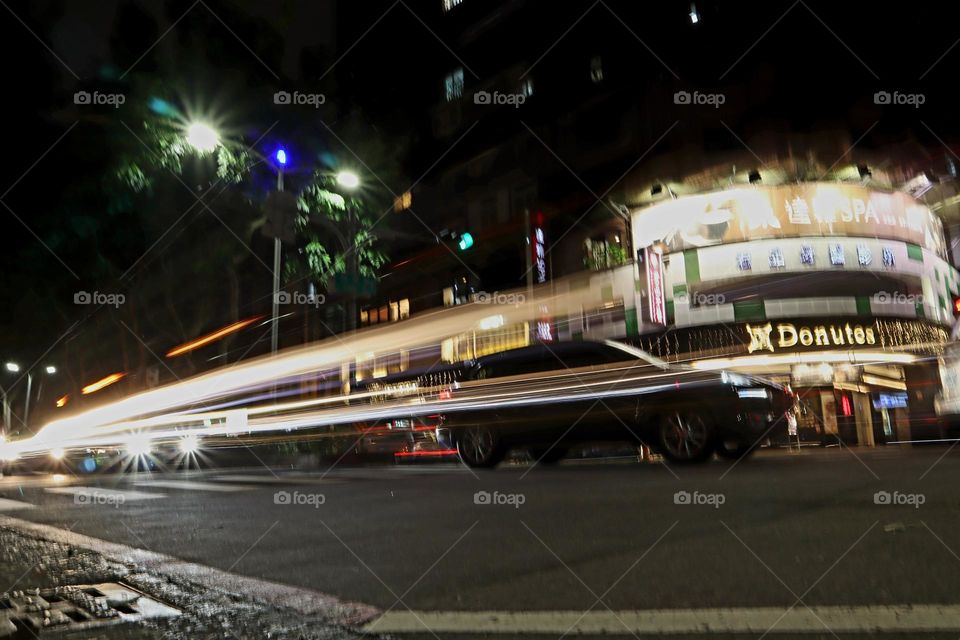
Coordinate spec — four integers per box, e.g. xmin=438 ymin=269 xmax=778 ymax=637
xmin=426 ymin=341 xmax=794 ymax=467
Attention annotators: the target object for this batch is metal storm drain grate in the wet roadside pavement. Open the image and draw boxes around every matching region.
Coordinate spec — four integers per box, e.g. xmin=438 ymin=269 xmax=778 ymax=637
xmin=0 ymin=582 xmax=180 ymax=638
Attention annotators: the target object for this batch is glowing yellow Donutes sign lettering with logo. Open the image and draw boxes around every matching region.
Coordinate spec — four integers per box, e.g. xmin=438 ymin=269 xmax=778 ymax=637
xmin=745 ymin=322 xmax=877 ymax=353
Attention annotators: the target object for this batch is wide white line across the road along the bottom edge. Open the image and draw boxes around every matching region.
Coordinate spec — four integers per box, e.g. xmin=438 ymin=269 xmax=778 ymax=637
xmin=363 ymin=604 xmax=960 ymax=636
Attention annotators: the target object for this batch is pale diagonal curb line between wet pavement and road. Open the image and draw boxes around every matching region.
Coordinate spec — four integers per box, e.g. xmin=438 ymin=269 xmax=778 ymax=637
xmin=0 ymin=516 xmax=380 ymax=625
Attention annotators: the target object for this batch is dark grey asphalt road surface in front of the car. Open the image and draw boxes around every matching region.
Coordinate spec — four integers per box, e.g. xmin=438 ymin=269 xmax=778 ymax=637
xmin=0 ymin=447 xmax=960 ymax=638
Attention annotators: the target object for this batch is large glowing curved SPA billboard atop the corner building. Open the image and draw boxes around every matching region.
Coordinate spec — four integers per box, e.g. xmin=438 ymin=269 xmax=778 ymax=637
xmin=633 ymin=183 xmax=946 ymax=257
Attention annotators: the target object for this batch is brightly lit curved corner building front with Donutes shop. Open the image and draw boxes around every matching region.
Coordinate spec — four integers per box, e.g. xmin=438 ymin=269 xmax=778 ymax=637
xmin=632 ymin=182 xmax=960 ymax=445
